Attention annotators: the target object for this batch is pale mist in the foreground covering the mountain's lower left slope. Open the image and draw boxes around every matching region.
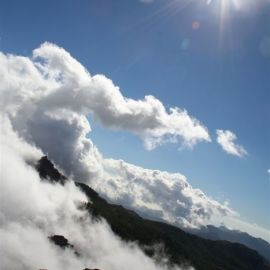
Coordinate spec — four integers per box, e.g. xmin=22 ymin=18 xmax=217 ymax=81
xmin=0 ymin=118 xmax=192 ymax=270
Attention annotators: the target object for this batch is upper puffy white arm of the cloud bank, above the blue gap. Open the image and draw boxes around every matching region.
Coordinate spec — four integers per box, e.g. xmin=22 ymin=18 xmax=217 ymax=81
xmin=4 ymin=43 xmax=211 ymax=150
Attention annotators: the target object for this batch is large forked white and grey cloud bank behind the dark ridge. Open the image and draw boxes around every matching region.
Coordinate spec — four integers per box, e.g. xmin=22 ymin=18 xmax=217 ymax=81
xmin=0 ymin=43 xmax=266 ymax=243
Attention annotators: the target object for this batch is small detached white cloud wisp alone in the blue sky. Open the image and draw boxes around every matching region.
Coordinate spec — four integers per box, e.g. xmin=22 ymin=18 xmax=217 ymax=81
xmin=216 ymin=129 xmax=247 ymax=157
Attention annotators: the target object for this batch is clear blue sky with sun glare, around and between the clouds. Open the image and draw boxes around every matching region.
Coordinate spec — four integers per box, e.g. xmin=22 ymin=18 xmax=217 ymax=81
xmin=0 ymin=0 xmax=270 ymax=234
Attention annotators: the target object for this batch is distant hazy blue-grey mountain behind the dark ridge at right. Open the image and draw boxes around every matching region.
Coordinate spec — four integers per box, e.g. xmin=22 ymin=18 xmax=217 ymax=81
xmin=188 ymin=225 xmax=270 ymax=261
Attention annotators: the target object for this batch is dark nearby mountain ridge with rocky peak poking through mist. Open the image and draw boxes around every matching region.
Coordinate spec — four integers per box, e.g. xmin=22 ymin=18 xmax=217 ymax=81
xmin=36 ymin=157 xmax=270 ymax=270
